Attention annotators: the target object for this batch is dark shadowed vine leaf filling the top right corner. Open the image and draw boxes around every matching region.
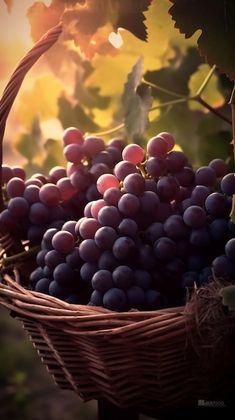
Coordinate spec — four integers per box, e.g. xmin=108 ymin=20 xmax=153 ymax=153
xmin=169 ymin=0 xmax=235 ymax=79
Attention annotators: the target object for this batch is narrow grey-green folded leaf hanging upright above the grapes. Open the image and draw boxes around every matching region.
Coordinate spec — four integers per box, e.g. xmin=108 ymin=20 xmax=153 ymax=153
xmin=122 ymin=57 xmax=152 ymax=142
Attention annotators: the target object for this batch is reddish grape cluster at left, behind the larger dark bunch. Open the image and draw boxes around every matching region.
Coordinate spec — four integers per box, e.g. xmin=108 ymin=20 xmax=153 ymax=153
xmin=0 ymin=127 xmax=124 ymax=245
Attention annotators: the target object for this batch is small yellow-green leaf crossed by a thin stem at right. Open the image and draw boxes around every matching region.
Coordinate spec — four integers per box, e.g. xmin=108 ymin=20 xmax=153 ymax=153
xmin=188 ymin=64 xmax=224 ymax=112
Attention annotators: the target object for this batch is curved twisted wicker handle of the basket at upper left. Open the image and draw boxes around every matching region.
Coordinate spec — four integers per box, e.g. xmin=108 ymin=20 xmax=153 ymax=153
xmin=0 ymin=22 xmax=62 ymax=211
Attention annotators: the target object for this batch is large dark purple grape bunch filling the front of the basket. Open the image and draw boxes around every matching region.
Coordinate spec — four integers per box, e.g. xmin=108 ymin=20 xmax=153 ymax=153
xmin=25 ymin=129 xmax=235 ymax=311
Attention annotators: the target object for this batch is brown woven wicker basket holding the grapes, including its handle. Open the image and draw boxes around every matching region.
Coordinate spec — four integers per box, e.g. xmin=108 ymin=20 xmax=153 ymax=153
xmin=0 ymin=24 xmax=235 ymax=412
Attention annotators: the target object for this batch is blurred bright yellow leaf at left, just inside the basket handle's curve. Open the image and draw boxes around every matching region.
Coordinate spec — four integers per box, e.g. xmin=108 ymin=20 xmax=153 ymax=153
xmin=16 ymin=75 xmax=64 ymax=128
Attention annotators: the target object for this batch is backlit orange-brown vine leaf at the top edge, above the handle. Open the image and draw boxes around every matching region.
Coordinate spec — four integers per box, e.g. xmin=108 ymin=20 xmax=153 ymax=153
xmin=28 ymin=0 xmax=151 ymax=58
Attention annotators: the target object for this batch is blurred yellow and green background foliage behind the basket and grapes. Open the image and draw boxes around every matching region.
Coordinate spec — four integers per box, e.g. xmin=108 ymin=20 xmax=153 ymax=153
xmin=0 ymin=0 xmax=232 ymax=420
